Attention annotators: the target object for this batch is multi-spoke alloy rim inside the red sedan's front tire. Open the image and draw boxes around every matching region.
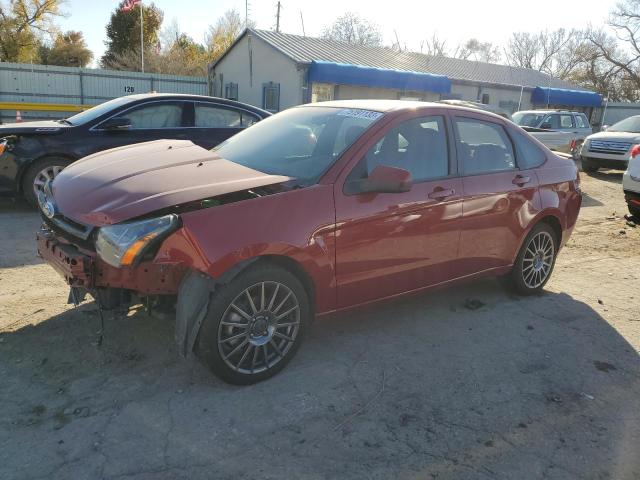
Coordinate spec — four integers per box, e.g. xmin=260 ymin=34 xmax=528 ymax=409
xmin=218 ymin=281 xmax=300 ymax=374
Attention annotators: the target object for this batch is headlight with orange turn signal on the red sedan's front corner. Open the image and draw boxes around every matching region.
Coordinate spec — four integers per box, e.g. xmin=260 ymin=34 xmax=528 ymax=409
xmin=96 ymin=215 xmax=180 ymax=267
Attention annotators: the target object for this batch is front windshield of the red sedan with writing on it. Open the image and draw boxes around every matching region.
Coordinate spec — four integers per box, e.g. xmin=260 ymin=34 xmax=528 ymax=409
xmin=214 ymin=107 xmax=382 ymax=184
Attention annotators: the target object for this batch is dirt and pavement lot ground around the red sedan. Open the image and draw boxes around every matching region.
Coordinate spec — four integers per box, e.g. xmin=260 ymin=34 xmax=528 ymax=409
xmin=0 ymin=172 xmax=640 ymax=480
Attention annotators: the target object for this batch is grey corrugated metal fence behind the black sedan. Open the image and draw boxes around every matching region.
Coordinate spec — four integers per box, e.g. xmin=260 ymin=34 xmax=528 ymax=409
xmin=0 ymin=62 xmax=209 ymax=123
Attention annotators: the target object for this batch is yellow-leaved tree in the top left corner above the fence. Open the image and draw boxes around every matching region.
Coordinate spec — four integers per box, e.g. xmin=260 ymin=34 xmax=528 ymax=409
xmin=0 ymin=0 xmax=61 ymax=62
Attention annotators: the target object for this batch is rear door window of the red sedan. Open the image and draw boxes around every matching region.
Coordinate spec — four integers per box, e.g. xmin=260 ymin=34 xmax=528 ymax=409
xmin=454 ymin=117 xmax=516 ymax=175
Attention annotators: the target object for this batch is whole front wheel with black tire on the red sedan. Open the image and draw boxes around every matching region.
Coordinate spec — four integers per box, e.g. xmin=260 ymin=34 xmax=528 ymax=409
xmin=195 ymin=263 xmax=311 ymax=385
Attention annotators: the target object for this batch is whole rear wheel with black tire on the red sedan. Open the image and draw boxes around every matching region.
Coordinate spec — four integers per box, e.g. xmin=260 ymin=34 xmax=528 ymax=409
xmin=510 ymin=223 xmax=559 ymax=295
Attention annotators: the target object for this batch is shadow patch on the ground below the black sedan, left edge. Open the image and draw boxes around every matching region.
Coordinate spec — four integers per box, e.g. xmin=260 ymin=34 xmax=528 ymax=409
xmin=0 ymin=199 xmax=43 ymax=268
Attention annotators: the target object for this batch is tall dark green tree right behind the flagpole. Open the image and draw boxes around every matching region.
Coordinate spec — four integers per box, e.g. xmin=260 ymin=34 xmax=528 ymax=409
xmin=100 ymin=2 xmax=164 ymax=70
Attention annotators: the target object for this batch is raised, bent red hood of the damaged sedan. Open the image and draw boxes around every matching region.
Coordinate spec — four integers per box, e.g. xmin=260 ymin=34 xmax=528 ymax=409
xmin=51 ymin=140 xmax=290 ymax=226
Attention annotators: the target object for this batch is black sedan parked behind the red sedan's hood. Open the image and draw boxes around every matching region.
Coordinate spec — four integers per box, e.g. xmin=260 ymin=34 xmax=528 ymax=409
xmin=0 ymin=93 xmax=271 ymax=205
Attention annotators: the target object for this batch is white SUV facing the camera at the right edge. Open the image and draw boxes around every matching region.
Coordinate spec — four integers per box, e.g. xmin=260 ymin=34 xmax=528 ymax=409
xmin=580 ymin=115 xmax=640 ymax=172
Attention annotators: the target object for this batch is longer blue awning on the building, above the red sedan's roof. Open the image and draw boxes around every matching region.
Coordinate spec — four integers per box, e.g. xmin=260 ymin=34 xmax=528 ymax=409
xmin=309 ymin=60 xmax=451 ymax=93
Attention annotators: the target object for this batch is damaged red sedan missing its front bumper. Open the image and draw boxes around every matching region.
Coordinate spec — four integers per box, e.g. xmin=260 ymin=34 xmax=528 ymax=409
xmin=38 ymin=100 xmax=581 ymax=384
